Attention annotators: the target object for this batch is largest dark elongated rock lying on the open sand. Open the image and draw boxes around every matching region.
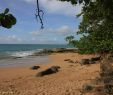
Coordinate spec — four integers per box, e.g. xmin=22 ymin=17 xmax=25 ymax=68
xmin=36 ymin=66 xmax=60 ymax=77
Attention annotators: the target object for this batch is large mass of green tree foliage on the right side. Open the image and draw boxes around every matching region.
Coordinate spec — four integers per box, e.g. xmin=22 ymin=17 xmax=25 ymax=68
xmin=61 ymin=0 xmax=113 ymax=53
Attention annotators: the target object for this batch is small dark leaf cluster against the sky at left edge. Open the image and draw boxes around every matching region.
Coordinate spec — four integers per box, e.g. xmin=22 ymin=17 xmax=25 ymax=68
xmin=0 ymin=8 xmax=17 ymax=29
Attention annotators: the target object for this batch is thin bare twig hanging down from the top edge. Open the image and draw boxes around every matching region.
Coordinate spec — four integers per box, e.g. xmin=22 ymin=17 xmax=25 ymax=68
xmin=35 ymin=0 xmax=44 ymax=29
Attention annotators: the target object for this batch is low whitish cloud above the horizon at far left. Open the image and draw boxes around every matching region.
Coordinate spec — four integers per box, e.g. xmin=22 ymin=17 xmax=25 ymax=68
xmin=0 ymin=35 xmax=22 ymax=43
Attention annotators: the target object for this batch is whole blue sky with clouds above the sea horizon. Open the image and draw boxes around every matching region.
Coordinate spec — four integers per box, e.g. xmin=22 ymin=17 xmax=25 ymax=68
xmin=0 ymin=0 xmax=81 ymax=44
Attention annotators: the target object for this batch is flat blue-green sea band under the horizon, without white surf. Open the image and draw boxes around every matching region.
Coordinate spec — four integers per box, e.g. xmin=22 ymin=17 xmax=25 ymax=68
xmin=0 ymin=44 xmax=70 ymax=52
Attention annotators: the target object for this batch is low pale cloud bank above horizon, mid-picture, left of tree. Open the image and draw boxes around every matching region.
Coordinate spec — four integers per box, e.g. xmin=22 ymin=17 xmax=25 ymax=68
xmin=30 ymin=25 xmax=76 ymax=44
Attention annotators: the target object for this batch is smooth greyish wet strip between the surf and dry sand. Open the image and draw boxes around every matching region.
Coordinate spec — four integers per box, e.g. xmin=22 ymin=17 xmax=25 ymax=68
xmin=0 ymin=55 xmax=50 ymax=68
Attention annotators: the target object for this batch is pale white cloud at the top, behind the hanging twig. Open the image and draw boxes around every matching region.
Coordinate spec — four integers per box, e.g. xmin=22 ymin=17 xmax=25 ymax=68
xmin=24 ymin=0 xmax=82 ymax=16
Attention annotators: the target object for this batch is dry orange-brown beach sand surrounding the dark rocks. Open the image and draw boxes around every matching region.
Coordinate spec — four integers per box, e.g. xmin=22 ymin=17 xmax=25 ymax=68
xmin=0 ymin=53 xmax=99 ymax=95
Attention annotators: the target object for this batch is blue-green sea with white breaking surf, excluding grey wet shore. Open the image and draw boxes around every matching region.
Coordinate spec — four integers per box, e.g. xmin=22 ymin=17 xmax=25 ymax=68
xmin=0 ymin=44 xmax=70 ymax=59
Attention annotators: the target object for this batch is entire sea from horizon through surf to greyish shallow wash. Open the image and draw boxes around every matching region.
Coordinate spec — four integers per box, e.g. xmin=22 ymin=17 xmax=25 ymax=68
xmin=0 ymin=44 xmax=72 ymax=67
